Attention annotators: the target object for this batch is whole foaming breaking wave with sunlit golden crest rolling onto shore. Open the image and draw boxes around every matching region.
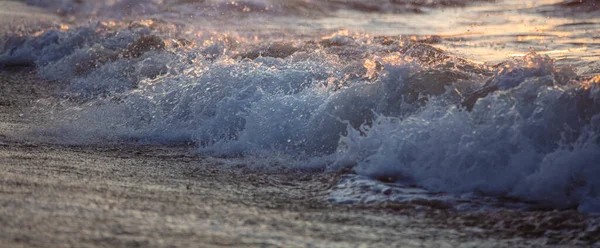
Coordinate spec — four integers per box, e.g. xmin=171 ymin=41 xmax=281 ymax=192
xmin=0 ymin=4 xmax=600 ymax=212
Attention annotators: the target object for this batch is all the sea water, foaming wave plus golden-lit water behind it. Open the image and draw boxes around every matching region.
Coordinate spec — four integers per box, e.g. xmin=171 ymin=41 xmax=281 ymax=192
xmin=0 ymin=0 xmax=600 ymax=212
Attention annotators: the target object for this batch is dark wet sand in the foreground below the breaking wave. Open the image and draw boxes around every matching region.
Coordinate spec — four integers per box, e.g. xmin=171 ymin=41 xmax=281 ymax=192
xmin=0 ymin=1 xmax=600 ymax=247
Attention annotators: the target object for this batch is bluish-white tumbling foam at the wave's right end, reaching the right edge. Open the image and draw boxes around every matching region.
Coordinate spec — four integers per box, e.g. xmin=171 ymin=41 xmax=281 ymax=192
xmin=333 ymin=59 xmax=600 ymax=211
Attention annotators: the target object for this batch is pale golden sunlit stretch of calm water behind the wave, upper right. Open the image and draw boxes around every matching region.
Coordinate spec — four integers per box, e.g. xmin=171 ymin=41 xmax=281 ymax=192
xmin=318 ymin=0 xmax=600 ymax=65
